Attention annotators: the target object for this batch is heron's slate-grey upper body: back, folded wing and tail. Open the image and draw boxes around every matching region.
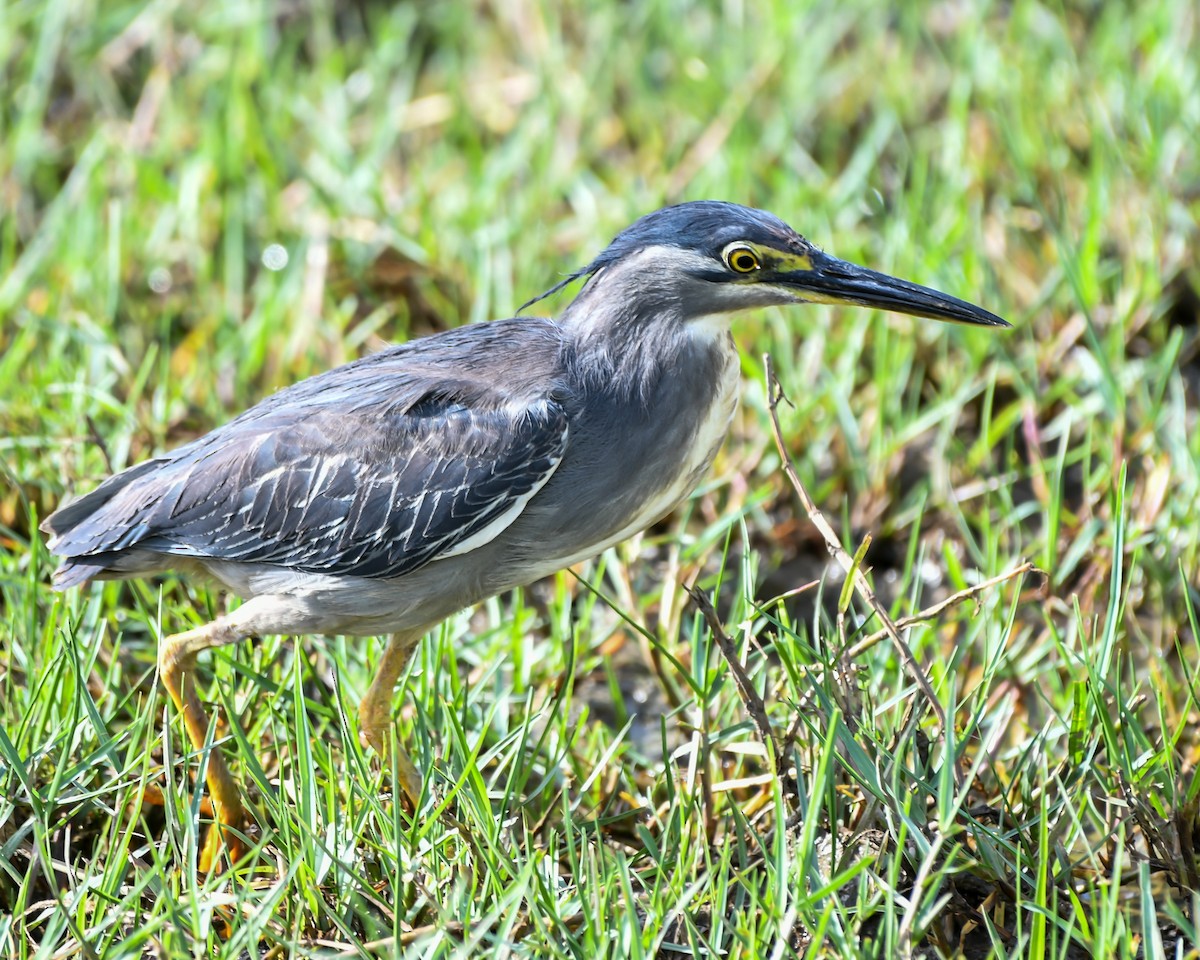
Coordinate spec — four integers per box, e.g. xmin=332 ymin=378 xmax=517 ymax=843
xmin=49 ymin=320 xmax=566 ymax=586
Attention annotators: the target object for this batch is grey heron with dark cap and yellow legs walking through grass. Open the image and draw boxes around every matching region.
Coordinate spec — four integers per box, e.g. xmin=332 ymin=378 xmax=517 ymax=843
xmin=42 ymin=200 xmax=1009 ymax=870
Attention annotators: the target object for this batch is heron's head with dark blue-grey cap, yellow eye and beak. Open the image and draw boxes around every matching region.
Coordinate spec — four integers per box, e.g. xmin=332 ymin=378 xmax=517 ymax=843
xmin=522 ymin=200 xmax=1009 ymax=326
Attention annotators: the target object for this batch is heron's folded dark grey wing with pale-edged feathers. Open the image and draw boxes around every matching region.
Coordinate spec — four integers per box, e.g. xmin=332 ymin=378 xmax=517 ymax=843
xmin=49 ymin=379 xmax=568 ymax=578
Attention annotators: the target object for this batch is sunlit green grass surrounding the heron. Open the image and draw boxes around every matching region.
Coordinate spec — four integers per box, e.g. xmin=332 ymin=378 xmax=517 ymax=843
xmin=0 ymin=0 xmax=1200 ymax=958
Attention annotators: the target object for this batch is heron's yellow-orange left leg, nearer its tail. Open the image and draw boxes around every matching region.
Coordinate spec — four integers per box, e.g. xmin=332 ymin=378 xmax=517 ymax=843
xmin=158 ymin=617 xmax=246 ymax=871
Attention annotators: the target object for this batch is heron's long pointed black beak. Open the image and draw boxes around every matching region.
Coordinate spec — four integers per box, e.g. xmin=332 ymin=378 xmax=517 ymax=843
xmin=776 ymin=250 xmax=1012 ymax=326
